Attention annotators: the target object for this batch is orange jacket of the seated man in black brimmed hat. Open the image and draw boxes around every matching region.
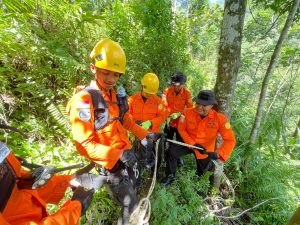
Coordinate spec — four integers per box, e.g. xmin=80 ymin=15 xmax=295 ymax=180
xmin=178 ymin=108 xmax=236 ymax=161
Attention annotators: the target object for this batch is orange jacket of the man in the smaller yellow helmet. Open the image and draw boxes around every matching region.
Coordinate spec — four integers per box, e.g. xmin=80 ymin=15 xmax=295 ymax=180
xmin=128 ymin=93 xmax=165 ymax=132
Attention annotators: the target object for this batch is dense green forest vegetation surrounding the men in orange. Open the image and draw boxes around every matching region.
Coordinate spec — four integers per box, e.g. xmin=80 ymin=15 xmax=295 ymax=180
xmin=0 ymin=0 xmax=300 ymax=224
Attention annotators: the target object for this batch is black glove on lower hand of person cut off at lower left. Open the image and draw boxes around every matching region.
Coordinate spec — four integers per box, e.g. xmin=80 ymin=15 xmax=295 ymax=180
xmin=72 ymin=187 xmax=95 ymax=216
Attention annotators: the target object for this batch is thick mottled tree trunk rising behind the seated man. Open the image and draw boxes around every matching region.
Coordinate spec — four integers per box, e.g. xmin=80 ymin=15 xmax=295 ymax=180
xmin=215 ymin=0 xmax=247 ymax=119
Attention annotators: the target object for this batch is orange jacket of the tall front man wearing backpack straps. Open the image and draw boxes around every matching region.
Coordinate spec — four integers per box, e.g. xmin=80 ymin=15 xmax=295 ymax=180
xmin=67 ymin=81 xmax=148 ymax=169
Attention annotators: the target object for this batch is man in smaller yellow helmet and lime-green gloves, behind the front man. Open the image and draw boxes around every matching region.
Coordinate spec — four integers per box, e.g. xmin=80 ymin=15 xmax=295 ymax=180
xmin=128 ymin=73 xmax=165 ymax=168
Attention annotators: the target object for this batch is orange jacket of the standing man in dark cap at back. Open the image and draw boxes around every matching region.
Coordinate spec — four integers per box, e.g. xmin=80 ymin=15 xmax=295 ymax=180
xmin=162 ymin=86 xmax=193 ymax=127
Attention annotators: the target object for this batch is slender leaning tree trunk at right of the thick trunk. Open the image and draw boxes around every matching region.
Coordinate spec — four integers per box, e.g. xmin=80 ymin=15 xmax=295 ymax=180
xmin=249 ymin=0 xmax=300 ymax=144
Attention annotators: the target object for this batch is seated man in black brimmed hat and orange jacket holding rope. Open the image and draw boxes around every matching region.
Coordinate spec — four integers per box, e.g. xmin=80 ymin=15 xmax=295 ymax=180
xmin=162 ymin=90 xmax=236 ymax=185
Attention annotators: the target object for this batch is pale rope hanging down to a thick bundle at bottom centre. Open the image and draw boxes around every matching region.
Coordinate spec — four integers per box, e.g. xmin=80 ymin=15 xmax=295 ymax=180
xmin=129 ymin=139 xmax=160 ymax=225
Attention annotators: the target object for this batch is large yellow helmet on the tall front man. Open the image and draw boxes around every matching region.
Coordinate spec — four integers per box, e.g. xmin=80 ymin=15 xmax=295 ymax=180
xmin=90 ymin=39 xmax=126 ymax=74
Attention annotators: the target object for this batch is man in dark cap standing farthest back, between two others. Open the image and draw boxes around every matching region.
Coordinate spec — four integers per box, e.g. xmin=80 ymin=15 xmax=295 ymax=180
xmin=162 ymin=71 xmax=193 ymax=165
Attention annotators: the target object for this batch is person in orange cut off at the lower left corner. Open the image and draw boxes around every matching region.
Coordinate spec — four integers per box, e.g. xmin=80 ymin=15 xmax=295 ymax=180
xmin=0 ymin=142 xmax=92 ymax=225
